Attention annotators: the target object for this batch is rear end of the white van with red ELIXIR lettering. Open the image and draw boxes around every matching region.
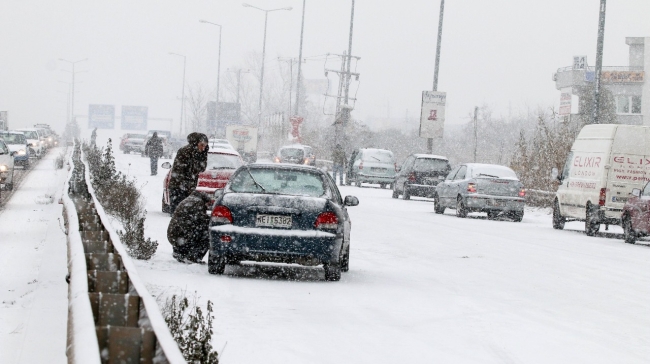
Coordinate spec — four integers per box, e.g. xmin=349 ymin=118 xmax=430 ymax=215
xmin=605 ymin=125 xmax=650 ymax=219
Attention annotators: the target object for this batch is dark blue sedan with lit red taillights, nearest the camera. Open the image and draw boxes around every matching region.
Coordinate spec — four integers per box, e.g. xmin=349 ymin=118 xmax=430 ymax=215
xmin=208 ymin=164 xmax=359 ymax=281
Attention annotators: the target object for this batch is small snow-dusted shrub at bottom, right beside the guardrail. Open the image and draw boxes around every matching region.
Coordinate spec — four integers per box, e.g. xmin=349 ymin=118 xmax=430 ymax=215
xmin=162 ymin=295 xmax=219 ymax=364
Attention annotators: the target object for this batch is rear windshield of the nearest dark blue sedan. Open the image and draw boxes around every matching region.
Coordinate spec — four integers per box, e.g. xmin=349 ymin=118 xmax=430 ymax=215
xmin=230 ymin=168 xmax=325 ymax=197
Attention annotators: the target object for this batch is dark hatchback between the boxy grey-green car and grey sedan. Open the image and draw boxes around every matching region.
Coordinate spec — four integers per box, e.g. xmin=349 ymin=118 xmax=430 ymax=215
xmin=393 ymin=154 xmax=451 ymax=200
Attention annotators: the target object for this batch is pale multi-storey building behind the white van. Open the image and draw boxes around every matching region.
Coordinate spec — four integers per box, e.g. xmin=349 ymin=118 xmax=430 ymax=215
xmin=553 ymin=37 xmax=650 ymax=125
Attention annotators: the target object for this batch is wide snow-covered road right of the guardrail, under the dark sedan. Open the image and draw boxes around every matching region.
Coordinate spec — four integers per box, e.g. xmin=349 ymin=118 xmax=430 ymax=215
xmin=102 ymin=141 xmax=650 ymax=363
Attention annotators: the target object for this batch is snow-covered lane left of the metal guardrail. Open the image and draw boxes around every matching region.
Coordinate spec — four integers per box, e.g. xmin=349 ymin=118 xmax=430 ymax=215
xmin=0 ymin=148 xmax=68 ymax=363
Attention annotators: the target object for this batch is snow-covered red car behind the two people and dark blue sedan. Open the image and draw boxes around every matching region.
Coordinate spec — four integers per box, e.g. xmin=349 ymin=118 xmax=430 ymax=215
xmin=162 ymin=149 xmax=244 ymax=213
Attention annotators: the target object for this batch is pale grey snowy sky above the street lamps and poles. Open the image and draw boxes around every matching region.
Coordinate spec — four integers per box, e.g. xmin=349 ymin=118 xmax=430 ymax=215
xmin=0 ymin=0 xmax=650 ymax=133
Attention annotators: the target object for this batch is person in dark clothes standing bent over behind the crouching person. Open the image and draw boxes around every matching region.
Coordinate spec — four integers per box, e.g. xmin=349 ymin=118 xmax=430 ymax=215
xmin=167 ymin=133 xmax=209 ymax=214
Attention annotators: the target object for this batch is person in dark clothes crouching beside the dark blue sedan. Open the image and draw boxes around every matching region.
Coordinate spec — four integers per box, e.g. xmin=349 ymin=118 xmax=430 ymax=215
xmin=167 ymin=190 xmax=210 ymax=263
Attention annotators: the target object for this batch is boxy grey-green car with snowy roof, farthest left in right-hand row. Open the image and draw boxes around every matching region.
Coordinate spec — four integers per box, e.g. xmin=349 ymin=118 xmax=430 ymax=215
xmin=345 ymin=148 xmax=397 ymax=189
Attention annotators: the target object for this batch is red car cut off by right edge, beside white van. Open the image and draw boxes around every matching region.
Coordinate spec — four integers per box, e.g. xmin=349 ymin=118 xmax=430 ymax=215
xmin=621 ymin=183 xmax=650 ymax=244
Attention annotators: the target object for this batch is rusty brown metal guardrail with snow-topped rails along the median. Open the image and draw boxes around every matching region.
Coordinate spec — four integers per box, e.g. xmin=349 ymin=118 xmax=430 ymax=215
xmin=62 ymin=143 xmax=186 ymax=364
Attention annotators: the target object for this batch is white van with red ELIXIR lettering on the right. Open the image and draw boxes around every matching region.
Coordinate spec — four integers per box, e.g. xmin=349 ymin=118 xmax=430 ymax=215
xmin=553 ymin=124 xmax=650 ymax=236
